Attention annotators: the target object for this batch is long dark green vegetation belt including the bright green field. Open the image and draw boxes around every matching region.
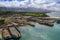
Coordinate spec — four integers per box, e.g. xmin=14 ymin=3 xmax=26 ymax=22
xmin=0 ymin=11 xmax=48 ymax=17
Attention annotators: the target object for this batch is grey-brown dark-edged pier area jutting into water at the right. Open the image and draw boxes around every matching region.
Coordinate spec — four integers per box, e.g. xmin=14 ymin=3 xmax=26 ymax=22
xmin=28 ymin=17 xmax=60 ymax=27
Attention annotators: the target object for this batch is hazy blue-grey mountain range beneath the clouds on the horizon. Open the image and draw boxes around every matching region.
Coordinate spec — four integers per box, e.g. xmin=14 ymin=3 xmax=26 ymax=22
xmin=0 ymin=7 xmax=50 ymax=12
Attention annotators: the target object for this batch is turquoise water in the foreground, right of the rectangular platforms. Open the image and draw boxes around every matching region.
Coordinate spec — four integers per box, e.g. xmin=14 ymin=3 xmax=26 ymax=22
xmin=18 ymin=23 xmax=60 ymax=40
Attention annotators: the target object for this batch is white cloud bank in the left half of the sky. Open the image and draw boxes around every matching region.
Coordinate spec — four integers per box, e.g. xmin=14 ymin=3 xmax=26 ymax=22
xmin=0 ymin=0 xmax=27 ymax=7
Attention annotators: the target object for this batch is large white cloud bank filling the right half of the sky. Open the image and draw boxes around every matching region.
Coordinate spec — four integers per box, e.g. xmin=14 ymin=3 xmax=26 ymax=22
xmin=30 ymin=0 xmax=60 ymax=11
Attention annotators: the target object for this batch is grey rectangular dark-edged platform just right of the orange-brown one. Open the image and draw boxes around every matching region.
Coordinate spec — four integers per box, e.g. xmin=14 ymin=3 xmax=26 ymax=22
xmin=8 ymin=27 xmax=21 ymax=40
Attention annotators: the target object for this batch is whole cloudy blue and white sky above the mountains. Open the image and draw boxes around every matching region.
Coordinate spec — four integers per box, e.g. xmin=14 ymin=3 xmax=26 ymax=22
xmin=0 ymin=0 xmax=60 ymax=11
